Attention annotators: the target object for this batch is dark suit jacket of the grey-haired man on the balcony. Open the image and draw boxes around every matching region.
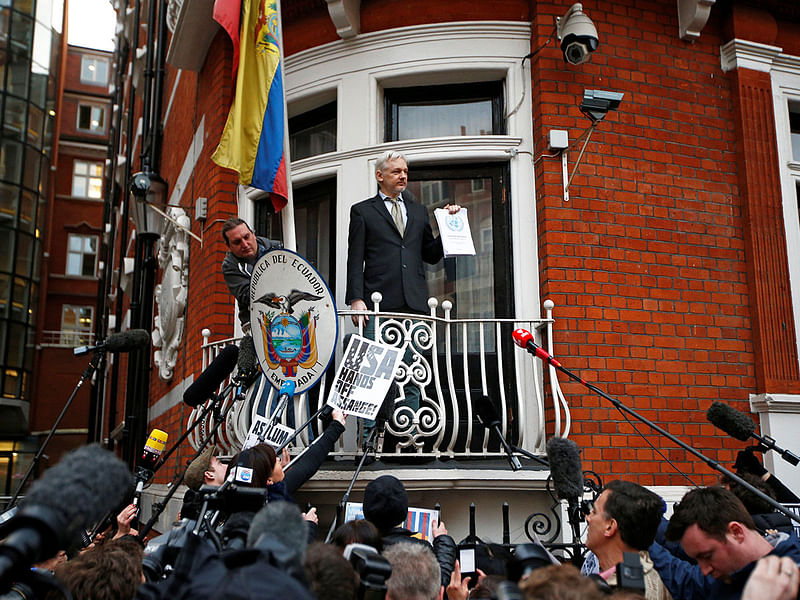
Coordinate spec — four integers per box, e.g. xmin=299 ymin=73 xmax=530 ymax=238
xmin=345 ymin=193 xmax=443 ymax=313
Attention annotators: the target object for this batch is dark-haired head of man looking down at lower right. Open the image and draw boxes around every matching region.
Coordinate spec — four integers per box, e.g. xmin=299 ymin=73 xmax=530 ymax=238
xmin=666 ymin=486 xmax=772 ymax=578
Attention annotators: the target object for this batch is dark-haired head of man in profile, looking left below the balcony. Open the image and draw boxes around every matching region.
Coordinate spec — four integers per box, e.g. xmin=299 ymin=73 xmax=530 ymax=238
xmin=586 ymin=480 xmax=664 ymax=552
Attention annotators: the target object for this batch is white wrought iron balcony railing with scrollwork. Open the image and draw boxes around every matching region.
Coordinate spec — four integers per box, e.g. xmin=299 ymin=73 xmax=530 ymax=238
xmin=187 ymin=295 xmax=571 ymax=458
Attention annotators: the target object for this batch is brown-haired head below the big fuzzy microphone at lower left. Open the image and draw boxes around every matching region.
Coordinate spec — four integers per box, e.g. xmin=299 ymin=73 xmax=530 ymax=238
xmin=55 ymin=538 xmax=144 ymax=600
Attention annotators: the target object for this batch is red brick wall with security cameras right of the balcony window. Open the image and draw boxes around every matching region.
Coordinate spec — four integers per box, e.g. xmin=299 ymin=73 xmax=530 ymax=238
xmin=533 ymin=2 xmax=755 ymax=485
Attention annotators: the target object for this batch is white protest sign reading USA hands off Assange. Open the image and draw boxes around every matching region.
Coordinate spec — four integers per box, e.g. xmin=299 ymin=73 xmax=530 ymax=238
xmin=327 ymin=335 xmax=405 ymax=420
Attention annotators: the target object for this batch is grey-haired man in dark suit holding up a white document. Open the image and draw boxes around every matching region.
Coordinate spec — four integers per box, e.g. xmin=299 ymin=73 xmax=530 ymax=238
xmin=345 ymin=151 xmax=461 ymax=448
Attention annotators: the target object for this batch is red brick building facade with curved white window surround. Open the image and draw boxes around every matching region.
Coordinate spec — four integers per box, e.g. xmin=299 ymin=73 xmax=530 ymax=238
xmin=98 ymin=0 xmax=800 ymax=536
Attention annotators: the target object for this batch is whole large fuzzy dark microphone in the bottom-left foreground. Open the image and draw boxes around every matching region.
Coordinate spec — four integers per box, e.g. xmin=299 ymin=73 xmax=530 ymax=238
xmin=0 ymin=445 xmax=131 ymax=591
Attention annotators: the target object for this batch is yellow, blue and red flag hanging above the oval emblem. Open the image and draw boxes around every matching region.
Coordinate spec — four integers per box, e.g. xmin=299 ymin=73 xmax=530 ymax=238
xmin=211 ymin=0 xmax=288 ymax=210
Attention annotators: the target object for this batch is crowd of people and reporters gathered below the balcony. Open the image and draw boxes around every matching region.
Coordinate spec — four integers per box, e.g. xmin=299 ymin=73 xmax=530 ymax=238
xmin=0 ymin=436 xmax=800 ymax=600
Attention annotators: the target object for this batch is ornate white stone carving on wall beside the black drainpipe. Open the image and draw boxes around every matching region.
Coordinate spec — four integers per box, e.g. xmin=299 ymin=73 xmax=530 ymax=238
xmin=153 ymin=206 xmax=191 ymax=381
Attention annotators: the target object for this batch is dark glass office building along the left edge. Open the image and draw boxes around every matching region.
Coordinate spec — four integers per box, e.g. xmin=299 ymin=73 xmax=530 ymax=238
xmin=0 ymin=0 xmax=64 ymax=454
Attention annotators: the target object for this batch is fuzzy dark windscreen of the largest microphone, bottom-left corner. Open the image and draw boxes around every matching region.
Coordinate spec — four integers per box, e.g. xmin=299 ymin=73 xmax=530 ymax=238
xmin=20 ymin=445 xmax=132 ymax=534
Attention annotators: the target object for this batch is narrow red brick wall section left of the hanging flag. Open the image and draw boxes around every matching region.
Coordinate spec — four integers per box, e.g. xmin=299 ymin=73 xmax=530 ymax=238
xmin=145 ymin=31 xmax=242 ymax=482
